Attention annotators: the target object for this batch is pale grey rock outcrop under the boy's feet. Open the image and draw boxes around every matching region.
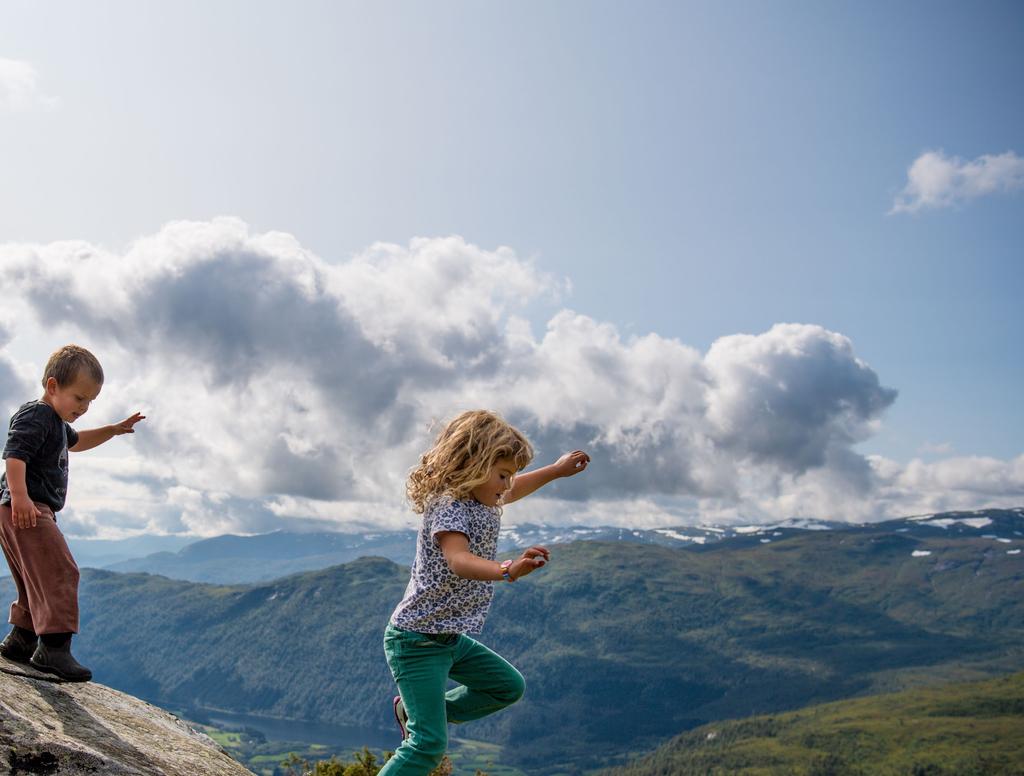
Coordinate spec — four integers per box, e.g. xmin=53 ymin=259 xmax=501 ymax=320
xmin=0 ymin=657 xmax=252 ymax=776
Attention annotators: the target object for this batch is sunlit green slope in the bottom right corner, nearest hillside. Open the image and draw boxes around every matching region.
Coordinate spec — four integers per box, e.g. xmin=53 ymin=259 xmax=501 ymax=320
xmin=602 ymin=674 xmax=1024 ymax=776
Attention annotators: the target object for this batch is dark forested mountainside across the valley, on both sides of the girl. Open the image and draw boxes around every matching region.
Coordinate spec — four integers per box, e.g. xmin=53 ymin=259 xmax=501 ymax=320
xmin=2 ymin=517 xmax=1024 ymax=773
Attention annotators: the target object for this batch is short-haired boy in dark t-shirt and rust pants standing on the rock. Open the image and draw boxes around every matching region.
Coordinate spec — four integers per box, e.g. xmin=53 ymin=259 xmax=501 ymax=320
xmin=0 ymin=345 xmax=143 ymax=682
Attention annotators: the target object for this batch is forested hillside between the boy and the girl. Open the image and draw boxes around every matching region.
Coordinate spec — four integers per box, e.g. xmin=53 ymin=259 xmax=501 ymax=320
xmin=77 ymin=558 xmax=409 ymax=727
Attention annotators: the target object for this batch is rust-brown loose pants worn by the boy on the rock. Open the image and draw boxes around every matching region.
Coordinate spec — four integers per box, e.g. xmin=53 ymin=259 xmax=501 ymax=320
xmin=0 ymin=502 xmax=78 ymax=636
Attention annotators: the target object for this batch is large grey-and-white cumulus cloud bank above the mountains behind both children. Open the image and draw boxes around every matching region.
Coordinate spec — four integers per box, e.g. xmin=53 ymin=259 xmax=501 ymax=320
xmin=0 ymin=218 xmax=1017 ymax=536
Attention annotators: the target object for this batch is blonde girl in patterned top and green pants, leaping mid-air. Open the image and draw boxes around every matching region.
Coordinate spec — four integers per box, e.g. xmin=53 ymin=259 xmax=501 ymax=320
xmin=380 ymin=411 xmax=590 ymax=776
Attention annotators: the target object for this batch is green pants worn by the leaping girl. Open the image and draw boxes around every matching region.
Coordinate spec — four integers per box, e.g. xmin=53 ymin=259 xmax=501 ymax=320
xmin=379 ymin=624 xmax=525 ymax=776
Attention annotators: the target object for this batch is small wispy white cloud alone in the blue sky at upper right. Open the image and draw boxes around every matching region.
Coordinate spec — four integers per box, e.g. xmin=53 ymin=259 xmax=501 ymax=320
xmin=889 ymin=150 xmax=1024 ymax=214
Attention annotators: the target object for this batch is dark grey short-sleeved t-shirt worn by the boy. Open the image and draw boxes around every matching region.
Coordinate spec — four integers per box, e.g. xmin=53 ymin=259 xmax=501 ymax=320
xmin=0 ymin=400 xmax=78 ymax=512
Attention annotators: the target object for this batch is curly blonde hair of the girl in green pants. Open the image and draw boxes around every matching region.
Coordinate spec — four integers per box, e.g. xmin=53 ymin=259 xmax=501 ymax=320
xmin=406 ymin=409 xmax=534 ymax=513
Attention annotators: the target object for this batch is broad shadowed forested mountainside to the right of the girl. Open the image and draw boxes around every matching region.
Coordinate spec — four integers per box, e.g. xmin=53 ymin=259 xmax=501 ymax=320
xmin=481 ymin=531 xmax=1024 ymax=767
